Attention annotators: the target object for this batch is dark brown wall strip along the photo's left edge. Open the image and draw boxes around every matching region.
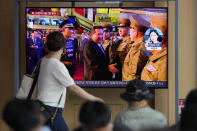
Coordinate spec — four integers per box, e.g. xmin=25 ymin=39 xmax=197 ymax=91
xmin=0 ymin=0 xmax=14 ymax=131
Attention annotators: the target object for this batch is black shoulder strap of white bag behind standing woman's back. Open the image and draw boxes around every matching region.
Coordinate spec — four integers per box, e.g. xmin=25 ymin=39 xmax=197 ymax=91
xmin=27 ymin=60 xmax=41 ymax=101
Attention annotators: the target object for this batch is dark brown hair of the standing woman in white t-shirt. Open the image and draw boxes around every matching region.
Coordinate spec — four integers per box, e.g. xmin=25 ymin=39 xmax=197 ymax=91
xmin=46 ymin=31 xmax=66 ymax=51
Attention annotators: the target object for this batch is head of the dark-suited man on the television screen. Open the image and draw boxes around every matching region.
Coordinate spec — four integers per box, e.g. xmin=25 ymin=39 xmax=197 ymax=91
xmin=91 ymin=26 xmax=103 ymax=43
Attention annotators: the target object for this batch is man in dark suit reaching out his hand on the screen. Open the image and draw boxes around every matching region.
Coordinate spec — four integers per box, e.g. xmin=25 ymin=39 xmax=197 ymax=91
xmin=83 ymin=26 xmax=118 ymax=80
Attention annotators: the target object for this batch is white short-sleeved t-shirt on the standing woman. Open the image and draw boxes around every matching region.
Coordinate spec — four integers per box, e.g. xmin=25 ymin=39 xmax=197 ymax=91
xmin=37 ymin=57 xmax=75 ymax=108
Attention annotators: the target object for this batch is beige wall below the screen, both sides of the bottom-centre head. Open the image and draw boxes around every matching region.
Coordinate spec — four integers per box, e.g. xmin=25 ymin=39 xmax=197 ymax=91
xmin=63 ymin=88 xmax=127 ymax=129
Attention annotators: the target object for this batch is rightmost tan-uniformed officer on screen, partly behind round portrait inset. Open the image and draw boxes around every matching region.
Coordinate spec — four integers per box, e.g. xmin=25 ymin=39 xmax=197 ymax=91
xmin=141 ymin=16 xmax=167 ymax=81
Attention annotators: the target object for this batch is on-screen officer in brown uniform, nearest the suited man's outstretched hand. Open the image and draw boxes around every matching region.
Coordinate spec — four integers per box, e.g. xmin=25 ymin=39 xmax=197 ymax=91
xmin=113 ymin=18 xmax=133 ymax=80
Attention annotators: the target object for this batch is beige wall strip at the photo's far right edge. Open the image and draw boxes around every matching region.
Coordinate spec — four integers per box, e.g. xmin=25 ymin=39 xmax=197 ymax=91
xmin=179 ymin=0 xmax=196 ymax=99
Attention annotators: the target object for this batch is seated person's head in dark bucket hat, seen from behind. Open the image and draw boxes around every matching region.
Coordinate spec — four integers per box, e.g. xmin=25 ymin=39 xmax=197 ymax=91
xmin=120 ymin=79 xmax=154 ymax=108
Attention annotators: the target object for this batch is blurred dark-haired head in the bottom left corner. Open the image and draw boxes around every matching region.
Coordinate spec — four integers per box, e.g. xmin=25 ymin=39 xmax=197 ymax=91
xmin=3 ymin=100 xmax=42 ymax=131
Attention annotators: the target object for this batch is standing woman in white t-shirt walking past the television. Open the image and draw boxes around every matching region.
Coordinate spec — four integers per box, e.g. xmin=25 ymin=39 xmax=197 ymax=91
xmin=37 ymin=31 xmax=103 ymax=131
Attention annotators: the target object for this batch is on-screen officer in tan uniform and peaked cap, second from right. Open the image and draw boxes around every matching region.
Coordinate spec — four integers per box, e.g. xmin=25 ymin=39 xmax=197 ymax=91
xmin=122 ymin=15 xmax=150 ymax=81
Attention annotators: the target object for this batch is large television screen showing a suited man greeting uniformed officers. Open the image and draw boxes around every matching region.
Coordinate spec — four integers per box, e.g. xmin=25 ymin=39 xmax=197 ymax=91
xmin=26 ymin=7 xmax=168 ymax=88
